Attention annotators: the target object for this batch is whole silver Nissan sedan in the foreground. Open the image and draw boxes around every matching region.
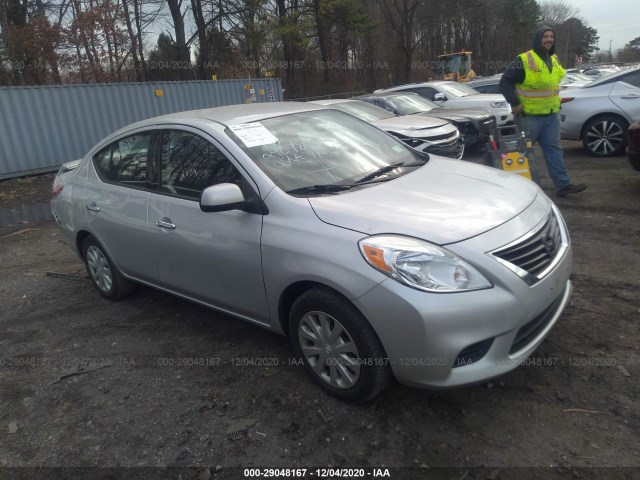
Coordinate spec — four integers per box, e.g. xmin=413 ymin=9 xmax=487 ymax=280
xmin=51 ymin=103 xmax=572 ymax=400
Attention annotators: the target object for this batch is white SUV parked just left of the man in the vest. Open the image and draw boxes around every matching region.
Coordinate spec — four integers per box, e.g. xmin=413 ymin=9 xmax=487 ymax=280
xmin=374 ymin=80 xmax=513 ymax=127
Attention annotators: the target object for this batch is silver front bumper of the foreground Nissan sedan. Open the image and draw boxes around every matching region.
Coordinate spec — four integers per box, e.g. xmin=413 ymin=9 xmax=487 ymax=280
xmin=356 ymin=201 xmax=572 ymax=388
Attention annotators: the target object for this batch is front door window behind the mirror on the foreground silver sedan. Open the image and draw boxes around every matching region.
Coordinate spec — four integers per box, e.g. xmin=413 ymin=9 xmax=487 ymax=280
xmin=161 ymin=130 xmax=242 ymax=200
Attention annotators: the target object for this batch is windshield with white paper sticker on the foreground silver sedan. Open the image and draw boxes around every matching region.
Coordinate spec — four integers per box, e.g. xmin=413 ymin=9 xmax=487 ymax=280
xmin=229 ymin=110 xmax=425 ymax=194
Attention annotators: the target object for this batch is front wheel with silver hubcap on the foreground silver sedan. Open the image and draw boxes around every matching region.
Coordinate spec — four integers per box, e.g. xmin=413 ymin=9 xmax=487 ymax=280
xmin=289 ymin=287 xmax=392 ymax=401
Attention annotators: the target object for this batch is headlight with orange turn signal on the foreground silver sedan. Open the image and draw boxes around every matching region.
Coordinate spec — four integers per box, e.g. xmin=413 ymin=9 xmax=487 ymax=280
xmin=358 ymin=235 xmax=492 ymax=293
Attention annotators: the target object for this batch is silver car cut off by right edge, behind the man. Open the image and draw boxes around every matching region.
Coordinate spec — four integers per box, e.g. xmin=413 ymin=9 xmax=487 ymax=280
xmin=560 ymin=68 xmax=640 ymax=157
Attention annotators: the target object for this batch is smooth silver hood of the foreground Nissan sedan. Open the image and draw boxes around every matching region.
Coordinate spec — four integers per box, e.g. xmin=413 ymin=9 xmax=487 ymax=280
xmin=309 ymin=156 xmax=540 ymax=245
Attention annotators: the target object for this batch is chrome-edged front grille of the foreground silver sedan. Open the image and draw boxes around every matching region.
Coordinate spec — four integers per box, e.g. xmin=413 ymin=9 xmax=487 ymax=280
xmin=492 ymin=208 xmax=568 ymax=285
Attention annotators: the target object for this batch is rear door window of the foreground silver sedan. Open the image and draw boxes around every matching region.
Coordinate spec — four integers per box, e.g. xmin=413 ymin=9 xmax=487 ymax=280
xmin=93 ymin=132 xmax=151 ymax=188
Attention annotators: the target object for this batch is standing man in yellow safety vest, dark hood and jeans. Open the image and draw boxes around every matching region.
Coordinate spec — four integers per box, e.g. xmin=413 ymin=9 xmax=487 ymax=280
xmin=500 ymin=27 xmax=587 ymax=197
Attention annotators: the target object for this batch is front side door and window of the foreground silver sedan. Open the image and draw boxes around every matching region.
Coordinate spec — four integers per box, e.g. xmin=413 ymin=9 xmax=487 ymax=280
xmin=149 ymin=126 xmax=268 ymax=322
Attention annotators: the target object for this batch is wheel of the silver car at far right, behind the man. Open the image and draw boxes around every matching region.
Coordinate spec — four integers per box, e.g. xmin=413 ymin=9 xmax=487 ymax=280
xmin=582 ymin=115 xmax=629 ymax=157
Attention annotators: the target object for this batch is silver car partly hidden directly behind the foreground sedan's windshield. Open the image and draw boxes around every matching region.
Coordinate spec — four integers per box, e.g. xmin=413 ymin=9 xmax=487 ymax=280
xmin=311 ymin=99 xmax=464 ymax=159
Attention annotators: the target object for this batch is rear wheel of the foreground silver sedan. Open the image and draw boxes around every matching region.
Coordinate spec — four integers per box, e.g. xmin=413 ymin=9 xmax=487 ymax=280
xmin=82 ymin=235 xmax=137 ymax=300
